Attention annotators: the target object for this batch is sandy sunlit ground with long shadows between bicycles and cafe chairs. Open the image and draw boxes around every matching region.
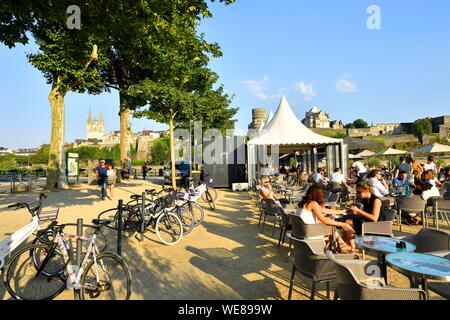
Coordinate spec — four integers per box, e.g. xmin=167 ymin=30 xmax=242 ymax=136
xmin=0 ymin=180 xmax=446 ymax=300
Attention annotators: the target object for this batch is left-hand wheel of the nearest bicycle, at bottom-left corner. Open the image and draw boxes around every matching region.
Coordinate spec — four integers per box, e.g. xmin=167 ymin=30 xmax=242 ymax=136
xmin=3 ymin=244 xmax=66 ymax=300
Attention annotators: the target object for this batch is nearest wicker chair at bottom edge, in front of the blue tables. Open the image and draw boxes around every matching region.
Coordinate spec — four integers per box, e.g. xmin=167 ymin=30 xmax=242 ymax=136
xmin=326 ymin=251 xmax=426 ymax=300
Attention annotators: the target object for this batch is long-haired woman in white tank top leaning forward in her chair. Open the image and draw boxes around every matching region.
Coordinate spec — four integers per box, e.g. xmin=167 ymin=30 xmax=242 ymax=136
xmin=296 ymin=186 xmax=356 ymax=253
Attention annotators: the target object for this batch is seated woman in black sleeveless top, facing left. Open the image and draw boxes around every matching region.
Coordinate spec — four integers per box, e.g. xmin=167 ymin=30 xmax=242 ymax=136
xmin=345 ymin=184 xmax=382 ymax=235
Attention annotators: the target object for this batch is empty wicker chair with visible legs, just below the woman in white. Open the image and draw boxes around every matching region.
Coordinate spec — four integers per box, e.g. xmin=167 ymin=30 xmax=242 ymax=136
xmin=288 ymin=235 xmax=355 ymax=300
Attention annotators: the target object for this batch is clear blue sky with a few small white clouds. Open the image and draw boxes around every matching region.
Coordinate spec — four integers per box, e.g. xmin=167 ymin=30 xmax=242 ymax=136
xmin=0 ymin=0 xmax=450 ymax=148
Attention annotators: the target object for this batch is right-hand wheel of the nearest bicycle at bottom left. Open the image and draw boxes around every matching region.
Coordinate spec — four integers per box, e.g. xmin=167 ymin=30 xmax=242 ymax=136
xmin=80 ymin=252 xmax=131 ymax=300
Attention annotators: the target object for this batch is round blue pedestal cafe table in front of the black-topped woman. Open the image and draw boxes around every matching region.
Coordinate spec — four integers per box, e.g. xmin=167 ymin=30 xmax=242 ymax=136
xmin=355 ymin=236 xmax=416 ymax=284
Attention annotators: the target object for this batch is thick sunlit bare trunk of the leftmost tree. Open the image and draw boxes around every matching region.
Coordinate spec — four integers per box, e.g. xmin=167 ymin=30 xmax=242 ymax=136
xmin=46 ymin=79 xmax=68 ymax=190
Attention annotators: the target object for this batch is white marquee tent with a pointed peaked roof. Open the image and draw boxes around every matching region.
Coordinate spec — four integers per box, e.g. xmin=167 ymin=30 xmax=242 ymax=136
xmin=247 ymin=97 xmax=348 ymax=183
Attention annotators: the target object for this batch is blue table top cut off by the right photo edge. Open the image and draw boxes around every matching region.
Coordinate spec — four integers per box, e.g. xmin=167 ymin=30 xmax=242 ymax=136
xmin=386 ymin=252 xmax=450 ymax=282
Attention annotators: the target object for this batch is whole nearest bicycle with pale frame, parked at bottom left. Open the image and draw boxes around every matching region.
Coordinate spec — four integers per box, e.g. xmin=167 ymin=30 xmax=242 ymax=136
xmin=3 ymin=220 xmax=131 ymax=300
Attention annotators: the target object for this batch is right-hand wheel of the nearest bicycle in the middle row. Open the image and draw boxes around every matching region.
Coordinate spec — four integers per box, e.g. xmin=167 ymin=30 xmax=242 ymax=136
xmin=155 ymin=212 xmax=183 ymax=246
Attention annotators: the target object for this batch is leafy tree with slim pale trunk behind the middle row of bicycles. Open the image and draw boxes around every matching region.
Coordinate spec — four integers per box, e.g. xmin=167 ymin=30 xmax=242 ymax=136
xmin=128 ymin=0 xmax=237 ymax=187
